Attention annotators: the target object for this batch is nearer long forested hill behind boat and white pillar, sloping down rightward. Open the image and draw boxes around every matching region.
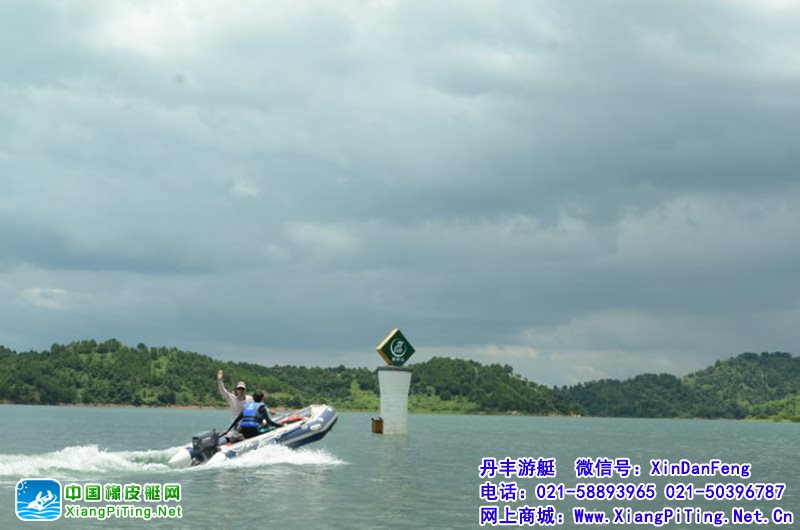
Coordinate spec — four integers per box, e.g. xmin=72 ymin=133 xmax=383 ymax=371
xmin=0 ymin=339 xmax=582 ymax=414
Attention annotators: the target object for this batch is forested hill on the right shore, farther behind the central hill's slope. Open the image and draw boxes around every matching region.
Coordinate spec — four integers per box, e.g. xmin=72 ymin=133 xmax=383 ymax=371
xmin=556 ymin=352 xmax=800 ymax=421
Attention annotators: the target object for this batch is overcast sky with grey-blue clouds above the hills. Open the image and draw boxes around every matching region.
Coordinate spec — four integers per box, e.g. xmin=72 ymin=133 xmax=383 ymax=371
xmin=0 ymin=0 xmax=800 ymax=385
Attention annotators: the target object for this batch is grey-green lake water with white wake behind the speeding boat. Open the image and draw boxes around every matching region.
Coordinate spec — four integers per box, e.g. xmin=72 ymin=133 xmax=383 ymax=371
xmin=0 ymin=405 xmax=800 ymax=530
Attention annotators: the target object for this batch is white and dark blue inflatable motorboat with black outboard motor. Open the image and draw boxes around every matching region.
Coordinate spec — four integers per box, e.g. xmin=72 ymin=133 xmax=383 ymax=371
xmin=169 ymin=405 xmax=339 ymax=468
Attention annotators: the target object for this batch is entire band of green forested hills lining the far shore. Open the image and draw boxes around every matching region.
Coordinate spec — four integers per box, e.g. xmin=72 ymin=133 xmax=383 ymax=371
xmin=0 ymin=339 xmax=800 ymax=421
